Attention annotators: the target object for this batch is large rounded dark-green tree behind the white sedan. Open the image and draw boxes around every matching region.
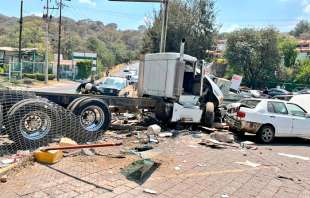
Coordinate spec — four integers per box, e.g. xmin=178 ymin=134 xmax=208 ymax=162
xmin=225 ymin=28 xmax=280 ymax=88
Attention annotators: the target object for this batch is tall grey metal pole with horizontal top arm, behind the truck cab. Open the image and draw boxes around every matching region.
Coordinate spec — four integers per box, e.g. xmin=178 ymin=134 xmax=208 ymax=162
xmin=109 ymin=0 xmax=169 ymax=53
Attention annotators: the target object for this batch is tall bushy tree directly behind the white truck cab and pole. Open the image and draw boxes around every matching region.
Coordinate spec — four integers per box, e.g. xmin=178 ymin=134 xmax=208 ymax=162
xmin=143 ymin=0 xmax=217 ymax=59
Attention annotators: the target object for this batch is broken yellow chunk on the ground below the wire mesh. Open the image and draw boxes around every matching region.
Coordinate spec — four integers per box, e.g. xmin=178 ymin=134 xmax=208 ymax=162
xmin=34 ymin=150 xmax=63 ymax=164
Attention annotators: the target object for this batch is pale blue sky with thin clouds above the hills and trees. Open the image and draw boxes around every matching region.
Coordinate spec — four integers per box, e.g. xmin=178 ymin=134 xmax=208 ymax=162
xmin=0 ymin=0 xmax=310 ymax=32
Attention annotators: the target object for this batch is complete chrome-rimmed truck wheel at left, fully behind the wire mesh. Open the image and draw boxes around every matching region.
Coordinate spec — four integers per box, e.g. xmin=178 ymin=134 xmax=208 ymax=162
xmin=8 ymin=99 xmax=59 ymax=150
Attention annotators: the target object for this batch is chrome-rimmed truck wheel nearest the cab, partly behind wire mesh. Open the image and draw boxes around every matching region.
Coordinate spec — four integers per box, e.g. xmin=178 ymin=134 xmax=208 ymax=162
xmin=72 ymin=98 xmax=111 ymax=141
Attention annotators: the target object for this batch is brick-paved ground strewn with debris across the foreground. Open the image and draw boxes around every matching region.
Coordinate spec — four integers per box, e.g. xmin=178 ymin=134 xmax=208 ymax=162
xmin=0 ymin=128 xmax=310 ymax=198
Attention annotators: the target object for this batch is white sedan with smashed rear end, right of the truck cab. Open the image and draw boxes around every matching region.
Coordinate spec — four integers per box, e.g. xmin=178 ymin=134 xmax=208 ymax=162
xmin=226 ymin=99 xmax=310 ymax=143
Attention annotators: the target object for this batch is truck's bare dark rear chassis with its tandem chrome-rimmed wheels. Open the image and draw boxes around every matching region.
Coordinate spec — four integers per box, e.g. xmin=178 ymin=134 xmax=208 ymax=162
xmin=0 ymin=90 xmax=161 ymax=149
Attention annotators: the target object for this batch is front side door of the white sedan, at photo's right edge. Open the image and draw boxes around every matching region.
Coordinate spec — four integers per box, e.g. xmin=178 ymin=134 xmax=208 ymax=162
xmin=286 ymin=103 xmax=310 ymax=137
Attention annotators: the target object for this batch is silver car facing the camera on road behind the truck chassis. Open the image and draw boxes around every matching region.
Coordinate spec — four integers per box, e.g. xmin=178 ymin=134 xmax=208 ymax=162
xmin=97 ymin=77 xmax=127 ymax=96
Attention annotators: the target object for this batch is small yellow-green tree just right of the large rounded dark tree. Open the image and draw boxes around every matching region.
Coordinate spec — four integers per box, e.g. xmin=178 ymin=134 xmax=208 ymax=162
xmin=279 ymin=37 xmax=298 ymax=67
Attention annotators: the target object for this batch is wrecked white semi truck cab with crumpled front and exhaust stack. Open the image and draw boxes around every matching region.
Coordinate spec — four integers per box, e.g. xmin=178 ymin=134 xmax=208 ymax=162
xmin=138 ymin=50 xmax=223 ymax=126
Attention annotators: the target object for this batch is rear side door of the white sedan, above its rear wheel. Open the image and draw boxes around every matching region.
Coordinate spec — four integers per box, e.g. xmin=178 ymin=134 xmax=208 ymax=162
xmin=267 ymin=101 xmax=293 ymax=136
